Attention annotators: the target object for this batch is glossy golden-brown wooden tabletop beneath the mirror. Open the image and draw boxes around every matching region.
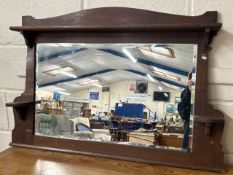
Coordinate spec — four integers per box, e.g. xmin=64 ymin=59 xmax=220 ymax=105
xmin=0 ymin=148 xmax=230 ymax=175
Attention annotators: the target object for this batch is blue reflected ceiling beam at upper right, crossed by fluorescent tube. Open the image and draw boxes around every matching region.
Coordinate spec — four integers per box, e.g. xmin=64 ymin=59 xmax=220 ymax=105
xmin=97 ymin=49 xmax=189 ymax=76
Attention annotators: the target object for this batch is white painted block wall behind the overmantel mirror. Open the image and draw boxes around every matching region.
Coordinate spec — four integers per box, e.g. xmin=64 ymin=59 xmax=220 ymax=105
xmin=0 ymin=0 xmax=233 ymax=164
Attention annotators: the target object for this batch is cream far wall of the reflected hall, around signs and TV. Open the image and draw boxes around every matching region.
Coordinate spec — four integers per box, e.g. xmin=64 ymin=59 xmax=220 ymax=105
xmin=71 ymin=80 xmax=181 ymax=117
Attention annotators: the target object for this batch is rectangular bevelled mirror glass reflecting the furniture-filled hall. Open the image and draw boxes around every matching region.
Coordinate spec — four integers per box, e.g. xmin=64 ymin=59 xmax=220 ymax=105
xmin=35 ymin=43 xmax=197 ymax=150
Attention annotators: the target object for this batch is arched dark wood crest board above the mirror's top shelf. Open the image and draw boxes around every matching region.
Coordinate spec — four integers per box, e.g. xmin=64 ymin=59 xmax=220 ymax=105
xmin=10 ymin=7 xmax=221 ymax=29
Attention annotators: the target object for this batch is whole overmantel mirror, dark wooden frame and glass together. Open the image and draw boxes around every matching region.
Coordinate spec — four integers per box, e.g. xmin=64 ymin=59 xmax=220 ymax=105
xmin=7 ymin=7 xmax=224 ymax=172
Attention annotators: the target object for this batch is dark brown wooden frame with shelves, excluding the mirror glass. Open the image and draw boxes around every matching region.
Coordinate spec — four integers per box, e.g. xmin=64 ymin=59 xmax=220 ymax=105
xmin=7 ymin=7 xmax=224 ymax=172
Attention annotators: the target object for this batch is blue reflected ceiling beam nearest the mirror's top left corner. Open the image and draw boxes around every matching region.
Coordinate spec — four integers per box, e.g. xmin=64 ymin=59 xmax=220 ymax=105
xmin=38 ymin=48 xmax=88 ymax=62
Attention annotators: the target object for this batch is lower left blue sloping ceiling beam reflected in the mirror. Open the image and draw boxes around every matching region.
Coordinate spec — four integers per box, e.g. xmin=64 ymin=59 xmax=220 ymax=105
xmin=38 ymin=69 xmax=116 ymax=88
